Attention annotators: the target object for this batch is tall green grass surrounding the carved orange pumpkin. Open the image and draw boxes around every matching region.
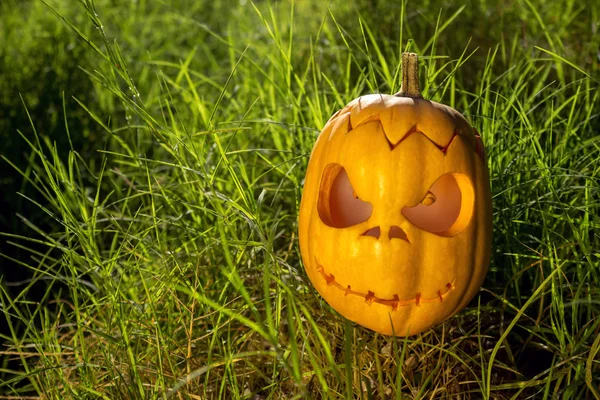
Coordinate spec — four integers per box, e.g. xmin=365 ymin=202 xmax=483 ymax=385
xmin=0 ymin=0 xmax=600 ymax=400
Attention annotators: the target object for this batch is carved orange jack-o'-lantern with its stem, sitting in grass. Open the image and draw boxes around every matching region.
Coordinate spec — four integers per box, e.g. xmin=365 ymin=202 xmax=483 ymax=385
xmin=299 ymin=53 xmax=492 ymax=336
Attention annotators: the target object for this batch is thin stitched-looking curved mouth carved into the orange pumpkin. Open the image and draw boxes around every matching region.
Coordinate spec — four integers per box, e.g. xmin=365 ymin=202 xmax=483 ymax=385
xmin=315 ymin=260 xmax=455 ymax=311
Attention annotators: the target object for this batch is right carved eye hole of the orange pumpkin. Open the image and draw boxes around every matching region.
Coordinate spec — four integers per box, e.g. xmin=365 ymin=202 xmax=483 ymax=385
xmin=402 ymin=173 xmax=475 ymax=236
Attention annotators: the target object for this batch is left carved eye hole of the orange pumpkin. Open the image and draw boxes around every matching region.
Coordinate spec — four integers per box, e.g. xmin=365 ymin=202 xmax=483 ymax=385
xmin=317 ymin=164 xmax=373 ymax=228
